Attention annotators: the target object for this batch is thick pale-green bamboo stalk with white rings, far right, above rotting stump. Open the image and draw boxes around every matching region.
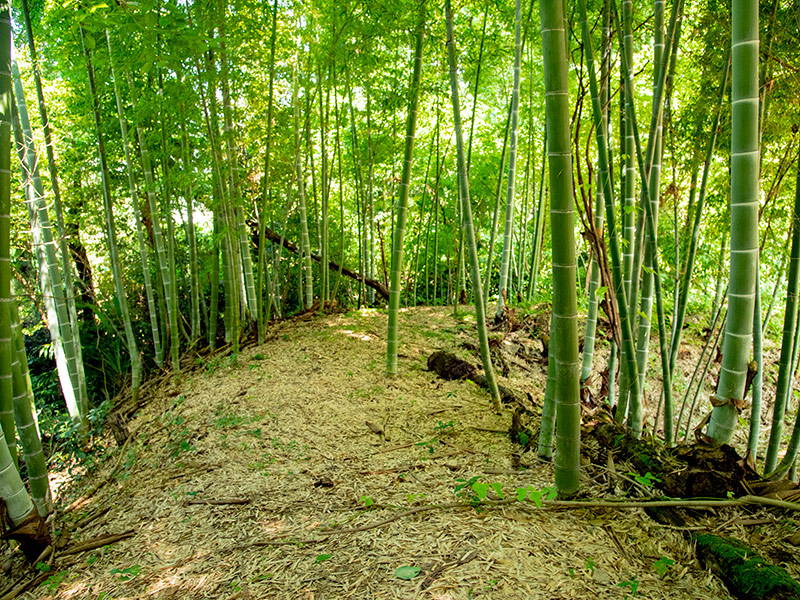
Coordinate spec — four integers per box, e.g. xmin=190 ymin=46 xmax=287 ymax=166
xmin=708 ymin=0 xmax=760 ymax=446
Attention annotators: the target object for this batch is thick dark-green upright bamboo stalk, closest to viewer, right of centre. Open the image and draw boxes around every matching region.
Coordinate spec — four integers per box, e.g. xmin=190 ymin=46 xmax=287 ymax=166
xmin=540 ymin=0 xmax=580 ymax=496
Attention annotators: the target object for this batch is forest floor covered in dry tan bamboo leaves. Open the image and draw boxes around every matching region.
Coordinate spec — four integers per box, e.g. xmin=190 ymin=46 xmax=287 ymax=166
xmin=6 ymin=308 xmax=800 ymax=600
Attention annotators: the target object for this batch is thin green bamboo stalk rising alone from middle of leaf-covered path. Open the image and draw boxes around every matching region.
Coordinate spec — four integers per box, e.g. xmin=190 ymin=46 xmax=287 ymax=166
xmin=386 ymin=0 xmax=426 ymax=376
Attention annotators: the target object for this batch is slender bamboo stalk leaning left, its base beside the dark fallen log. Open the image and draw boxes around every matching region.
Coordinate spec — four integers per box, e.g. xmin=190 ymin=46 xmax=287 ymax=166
xmin=444 ymin=0 xmax=500 ymax=412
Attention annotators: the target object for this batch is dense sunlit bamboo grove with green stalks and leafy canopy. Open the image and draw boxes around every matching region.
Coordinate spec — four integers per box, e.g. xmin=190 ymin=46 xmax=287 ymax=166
xmin=0 ymin=0 xmax=800 ymax=540
